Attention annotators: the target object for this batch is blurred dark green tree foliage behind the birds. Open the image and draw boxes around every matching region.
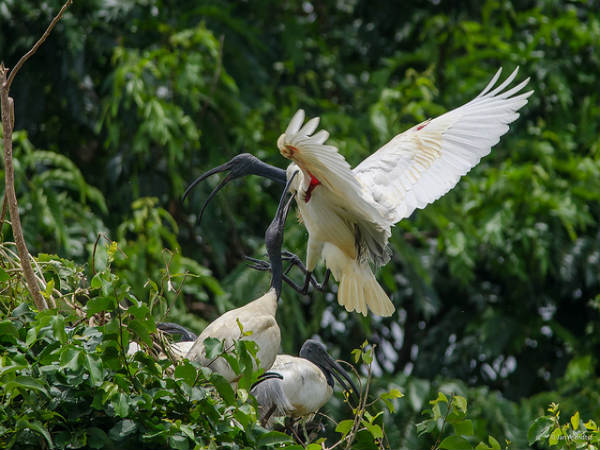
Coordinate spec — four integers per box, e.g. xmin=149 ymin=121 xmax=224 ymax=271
xmin=0 ymin=0 xmax=600 ymax=448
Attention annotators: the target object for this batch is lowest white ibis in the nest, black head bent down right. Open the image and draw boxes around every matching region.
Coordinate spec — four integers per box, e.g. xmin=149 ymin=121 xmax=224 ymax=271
xmin=251 ymin=339 xmax=359 ymax=423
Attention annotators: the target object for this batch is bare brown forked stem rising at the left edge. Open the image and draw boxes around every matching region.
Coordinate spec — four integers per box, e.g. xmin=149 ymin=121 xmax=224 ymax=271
xmin=0 ymin=0 xmax=73 ymax=311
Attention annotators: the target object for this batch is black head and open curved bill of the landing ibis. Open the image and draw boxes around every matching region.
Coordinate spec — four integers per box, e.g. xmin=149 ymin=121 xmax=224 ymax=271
xmin=182 ymin=153 xmax=286 ymax=220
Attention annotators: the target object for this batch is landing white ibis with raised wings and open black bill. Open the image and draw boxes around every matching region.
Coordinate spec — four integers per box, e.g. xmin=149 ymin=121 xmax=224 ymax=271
xmin=185 ymin=68 xmax=533 ymax=316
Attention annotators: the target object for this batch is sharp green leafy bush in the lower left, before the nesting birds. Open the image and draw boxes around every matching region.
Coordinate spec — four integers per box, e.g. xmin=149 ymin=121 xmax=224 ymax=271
xmin=0 ymin=253 xmax=291 ymax=449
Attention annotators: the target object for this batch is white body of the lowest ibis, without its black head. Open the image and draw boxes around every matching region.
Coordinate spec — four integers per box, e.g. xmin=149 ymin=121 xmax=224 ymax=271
xmin=254 ymin=355 xmax=333 ymax=417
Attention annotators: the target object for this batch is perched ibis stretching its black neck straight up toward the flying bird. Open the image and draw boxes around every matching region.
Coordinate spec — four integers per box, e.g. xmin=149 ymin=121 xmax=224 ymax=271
xmin=186 ymin=172 xmax=294 ymax=382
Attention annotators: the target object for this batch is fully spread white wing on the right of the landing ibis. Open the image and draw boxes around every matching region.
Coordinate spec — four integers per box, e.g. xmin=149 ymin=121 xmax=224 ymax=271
xmin=353 ymin=68 xmax=533 ymax=223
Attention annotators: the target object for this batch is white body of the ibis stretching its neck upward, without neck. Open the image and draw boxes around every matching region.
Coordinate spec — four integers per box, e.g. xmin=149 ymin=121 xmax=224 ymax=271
xmin=186 ymin=288 xmax=281 ymax=382
